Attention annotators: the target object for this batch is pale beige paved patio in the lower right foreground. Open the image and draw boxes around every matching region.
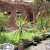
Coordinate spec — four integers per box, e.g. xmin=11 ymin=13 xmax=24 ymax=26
xmin=24 ymin=38 xmax=50 ymax=50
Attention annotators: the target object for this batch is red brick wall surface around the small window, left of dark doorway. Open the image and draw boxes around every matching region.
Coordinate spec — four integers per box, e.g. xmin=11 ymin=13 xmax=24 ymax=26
xmin=0 ymin=2 xmax=28 ymax=27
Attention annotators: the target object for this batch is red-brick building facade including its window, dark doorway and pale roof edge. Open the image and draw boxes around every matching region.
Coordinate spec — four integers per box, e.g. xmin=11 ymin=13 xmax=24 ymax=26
xmin=0 ymin=0 xmax=50 ymax=27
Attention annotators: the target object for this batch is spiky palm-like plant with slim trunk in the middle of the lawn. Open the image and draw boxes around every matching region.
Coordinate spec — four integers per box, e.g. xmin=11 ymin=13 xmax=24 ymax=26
xmin=16 ymin=17 xmax=31 ymax=40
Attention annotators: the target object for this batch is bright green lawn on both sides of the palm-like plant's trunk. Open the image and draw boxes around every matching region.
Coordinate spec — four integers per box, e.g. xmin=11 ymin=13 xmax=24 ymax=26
xmin=0 ymin=32 xmax=32 ymax=45
